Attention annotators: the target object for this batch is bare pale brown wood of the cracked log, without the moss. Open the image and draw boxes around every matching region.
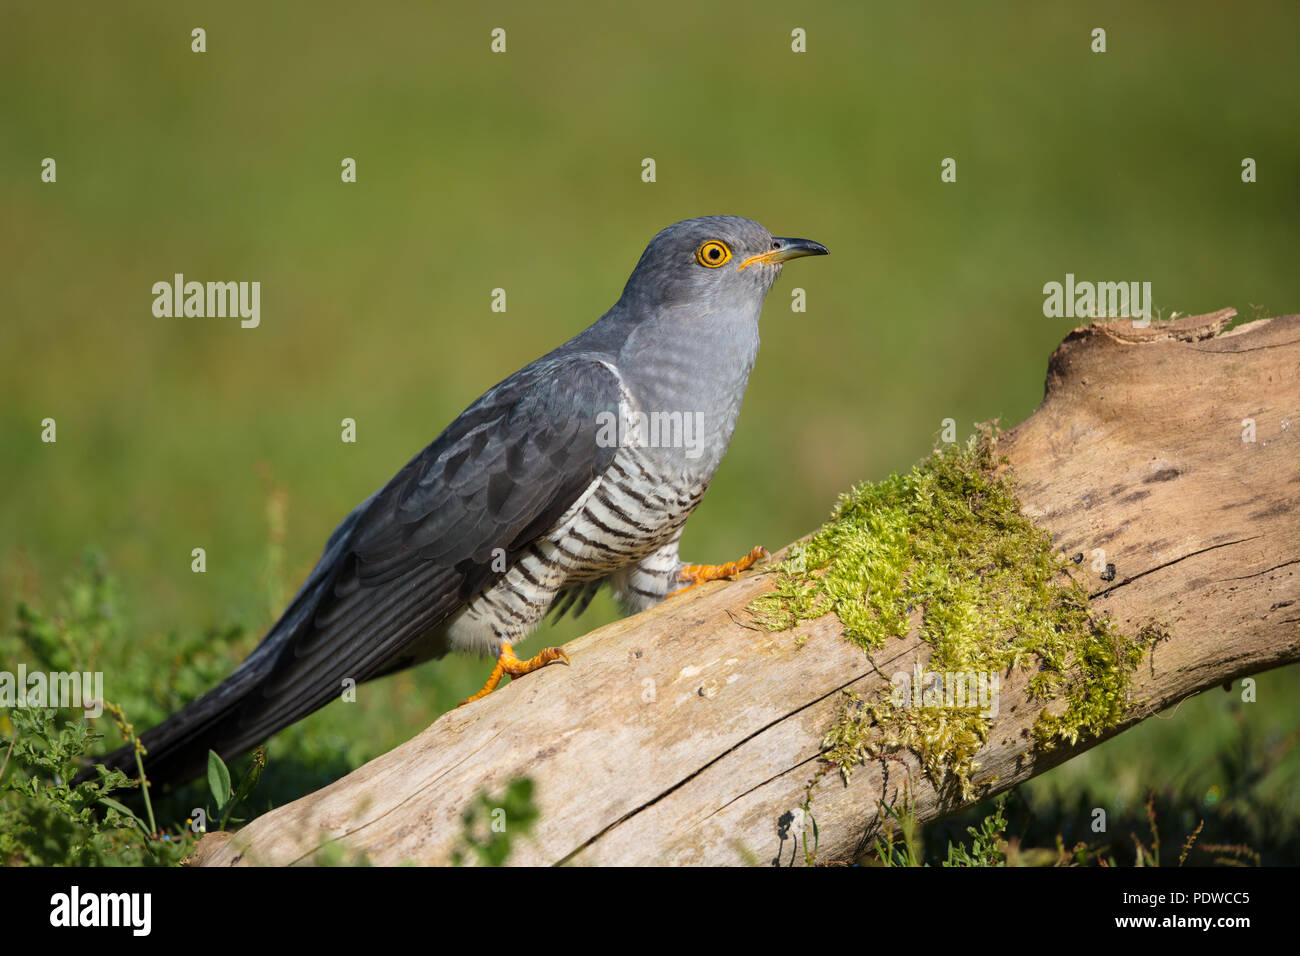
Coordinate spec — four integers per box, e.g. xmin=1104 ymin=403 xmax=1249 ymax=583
xmin=192 ymin=310 xmax=1300 ymax=865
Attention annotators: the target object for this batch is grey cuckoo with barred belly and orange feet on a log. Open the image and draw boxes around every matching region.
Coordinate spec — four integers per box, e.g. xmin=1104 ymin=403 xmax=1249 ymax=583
xmin=78 ymin=216 xmax=828 ymax=790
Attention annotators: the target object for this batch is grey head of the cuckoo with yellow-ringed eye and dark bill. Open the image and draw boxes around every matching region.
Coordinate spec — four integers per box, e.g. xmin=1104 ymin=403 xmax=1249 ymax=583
xmin=623 ymin=216 xmax=828 ymax=317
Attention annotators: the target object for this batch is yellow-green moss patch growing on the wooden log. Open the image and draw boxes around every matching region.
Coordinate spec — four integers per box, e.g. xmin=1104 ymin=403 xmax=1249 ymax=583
xmin=751 ymin=429 xmax=1153 ymax=800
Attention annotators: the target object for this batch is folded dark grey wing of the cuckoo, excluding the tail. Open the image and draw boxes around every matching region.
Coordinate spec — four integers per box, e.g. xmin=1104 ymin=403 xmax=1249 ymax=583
xmin=253 ymin=354 xmax=620 ymax=712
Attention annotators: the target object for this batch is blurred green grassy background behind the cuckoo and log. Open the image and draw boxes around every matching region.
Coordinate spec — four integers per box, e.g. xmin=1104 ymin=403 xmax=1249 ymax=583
xmin=0 ymin=0 xmax=1300 ymax=861
